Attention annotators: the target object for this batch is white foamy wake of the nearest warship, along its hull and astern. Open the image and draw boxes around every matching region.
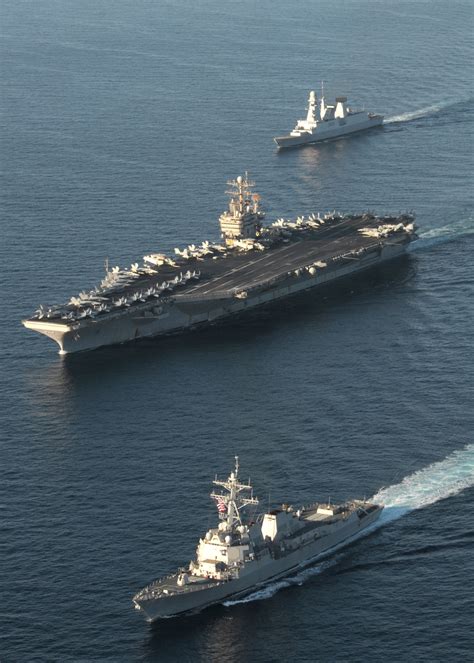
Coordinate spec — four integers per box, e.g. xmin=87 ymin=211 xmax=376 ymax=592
xmin=224 ymin=444 xmax=474 ymax=606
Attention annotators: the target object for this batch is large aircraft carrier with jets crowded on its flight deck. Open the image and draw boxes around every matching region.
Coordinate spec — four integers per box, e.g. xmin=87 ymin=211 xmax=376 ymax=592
xmin=23 ymin=174 xmax=416 ymax=354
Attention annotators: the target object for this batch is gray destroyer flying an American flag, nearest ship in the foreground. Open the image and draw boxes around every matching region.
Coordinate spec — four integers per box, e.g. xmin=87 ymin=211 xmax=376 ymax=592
xmin=133 ymin=456 xmax=383 ymax=622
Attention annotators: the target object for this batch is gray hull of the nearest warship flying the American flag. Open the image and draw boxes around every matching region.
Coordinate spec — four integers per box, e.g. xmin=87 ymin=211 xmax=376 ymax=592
xmin=137 ymin=509 xmax=381 ymax=622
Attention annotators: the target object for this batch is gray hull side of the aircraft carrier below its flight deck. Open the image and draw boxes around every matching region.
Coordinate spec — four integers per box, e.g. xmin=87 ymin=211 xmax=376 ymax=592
xmin=24 ymin=239 xmax=408 ymax=354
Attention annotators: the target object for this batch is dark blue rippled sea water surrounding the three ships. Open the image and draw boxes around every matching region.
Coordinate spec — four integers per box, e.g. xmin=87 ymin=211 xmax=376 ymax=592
xmin=0 ymin=0 xmax=474 ymax=663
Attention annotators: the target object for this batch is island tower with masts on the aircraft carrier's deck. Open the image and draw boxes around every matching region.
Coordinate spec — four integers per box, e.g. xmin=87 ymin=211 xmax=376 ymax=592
xmin=219 ymin=173 xmax=265 ymax=246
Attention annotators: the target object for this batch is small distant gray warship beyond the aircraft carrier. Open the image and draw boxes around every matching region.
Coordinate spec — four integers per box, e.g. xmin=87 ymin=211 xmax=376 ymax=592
xmin=273 ymin=90 xmax=383 ymax=148
